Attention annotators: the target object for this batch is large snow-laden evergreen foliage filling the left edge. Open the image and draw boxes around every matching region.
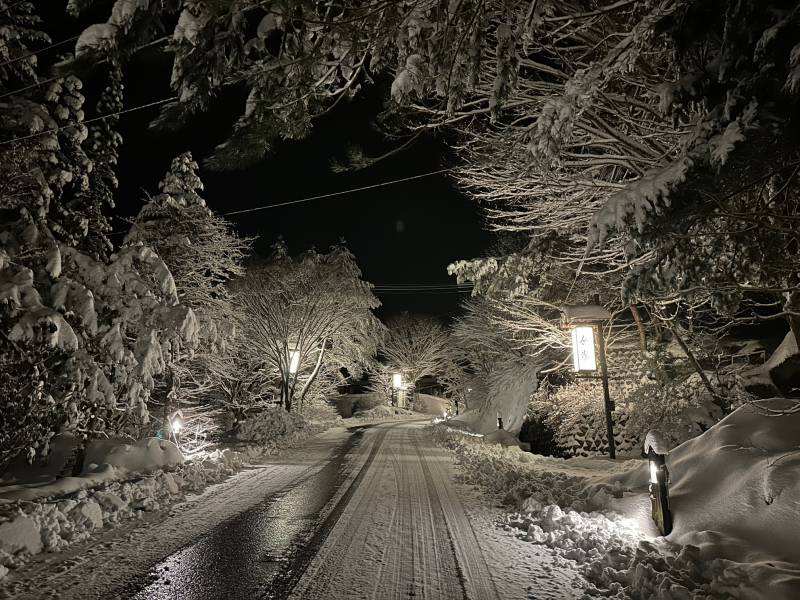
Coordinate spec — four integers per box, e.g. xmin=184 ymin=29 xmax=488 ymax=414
xmin=0 ymin=2 xmax=195 ymax=468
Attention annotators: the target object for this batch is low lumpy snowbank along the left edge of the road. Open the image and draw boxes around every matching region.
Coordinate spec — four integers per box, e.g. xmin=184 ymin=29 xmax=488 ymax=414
xmin=0 ymin=410 xmax=341 ymax=580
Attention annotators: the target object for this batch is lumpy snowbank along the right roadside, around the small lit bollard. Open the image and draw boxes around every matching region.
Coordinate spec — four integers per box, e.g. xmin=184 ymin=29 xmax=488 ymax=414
xmin=434 ymin=400 xmax=800 ymax=600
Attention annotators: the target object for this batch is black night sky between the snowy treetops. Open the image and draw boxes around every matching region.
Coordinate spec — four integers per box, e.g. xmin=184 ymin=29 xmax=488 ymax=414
xmin=110 ymin=48 xmax=488 ymax=317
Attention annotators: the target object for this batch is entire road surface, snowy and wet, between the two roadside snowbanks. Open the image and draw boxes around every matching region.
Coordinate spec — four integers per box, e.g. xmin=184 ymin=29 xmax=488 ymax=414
xmin=4 ymin=423 xmax=582 ymax=600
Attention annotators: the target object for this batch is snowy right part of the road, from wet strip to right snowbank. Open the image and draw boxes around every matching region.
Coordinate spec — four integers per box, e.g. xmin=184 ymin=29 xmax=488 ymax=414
xmin=291 ymin=423 xmax=582 ymax=600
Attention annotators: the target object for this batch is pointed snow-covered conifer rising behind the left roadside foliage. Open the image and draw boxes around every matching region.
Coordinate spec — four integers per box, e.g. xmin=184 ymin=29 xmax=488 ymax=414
xmin=125 ymin=152 xmax=249 ymax=428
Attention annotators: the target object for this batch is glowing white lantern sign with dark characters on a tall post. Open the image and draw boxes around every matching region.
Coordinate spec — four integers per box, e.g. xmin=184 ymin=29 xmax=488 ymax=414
xmin=562 ymin=295 xmax=617 ymax=459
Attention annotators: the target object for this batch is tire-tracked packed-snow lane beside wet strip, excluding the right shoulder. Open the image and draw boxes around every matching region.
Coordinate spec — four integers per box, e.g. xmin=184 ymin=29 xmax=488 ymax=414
xmin=292 ymin=425 xmax=499 ymax=600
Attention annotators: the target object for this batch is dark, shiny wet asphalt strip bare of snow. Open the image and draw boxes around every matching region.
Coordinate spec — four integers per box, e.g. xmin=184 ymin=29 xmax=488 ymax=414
xmin=127 ymin=428 xmax=372 ymax=600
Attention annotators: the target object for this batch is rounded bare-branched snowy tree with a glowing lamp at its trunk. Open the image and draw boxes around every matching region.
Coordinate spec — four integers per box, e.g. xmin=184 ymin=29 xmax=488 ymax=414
xmin=241 ymin=241 xmax=383 ymax=411
